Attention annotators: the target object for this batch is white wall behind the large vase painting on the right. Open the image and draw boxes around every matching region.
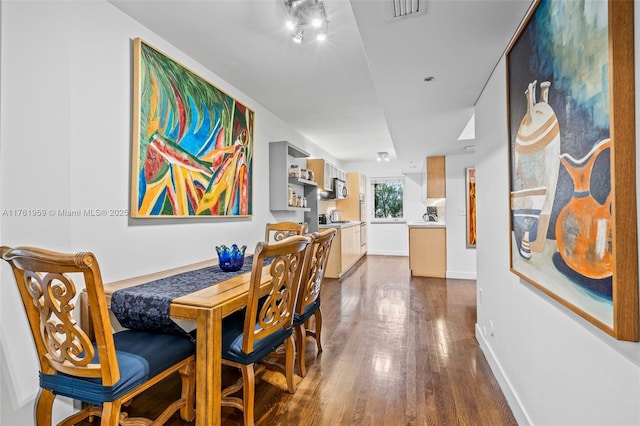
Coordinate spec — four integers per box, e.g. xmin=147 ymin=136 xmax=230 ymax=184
xmin=476 ymin=1 xmax=640 ymax=425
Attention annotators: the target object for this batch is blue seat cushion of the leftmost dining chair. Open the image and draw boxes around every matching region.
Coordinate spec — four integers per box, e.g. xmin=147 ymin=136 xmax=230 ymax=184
xmin=40 ymin=330 xmax=195 ymax=405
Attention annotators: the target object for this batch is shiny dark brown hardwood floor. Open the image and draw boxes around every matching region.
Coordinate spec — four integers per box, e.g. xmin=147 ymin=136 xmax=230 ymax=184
xmin=86 ymin=256 xmax=517 ymax=426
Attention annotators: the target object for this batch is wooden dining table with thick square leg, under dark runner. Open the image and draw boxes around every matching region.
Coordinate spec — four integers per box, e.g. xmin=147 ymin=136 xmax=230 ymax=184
xmin=80 ymin=259 xmax=271 ymax=426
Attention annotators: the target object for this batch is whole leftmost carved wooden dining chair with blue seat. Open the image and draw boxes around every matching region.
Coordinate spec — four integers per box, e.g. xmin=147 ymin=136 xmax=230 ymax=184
xmin=0 ymin=247 xmax=195 ymax=426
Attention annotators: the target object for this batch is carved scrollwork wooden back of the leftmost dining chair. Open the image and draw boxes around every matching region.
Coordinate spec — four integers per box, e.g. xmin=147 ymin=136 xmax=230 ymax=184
xmin=0 ymin=247 xmax=120 ymax=386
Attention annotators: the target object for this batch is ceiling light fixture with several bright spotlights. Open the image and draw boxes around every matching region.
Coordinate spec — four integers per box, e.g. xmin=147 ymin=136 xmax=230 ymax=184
xmin=284 ymin=0 xmax=329 ymax=43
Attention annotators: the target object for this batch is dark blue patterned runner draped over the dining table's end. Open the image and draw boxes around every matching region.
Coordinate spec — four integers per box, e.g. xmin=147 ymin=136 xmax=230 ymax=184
xmin=111 ymin=256 xmax=258 ymax=334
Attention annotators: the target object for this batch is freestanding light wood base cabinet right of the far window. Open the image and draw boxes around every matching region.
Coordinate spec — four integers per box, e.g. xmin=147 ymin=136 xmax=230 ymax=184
xmin=409 ymin=224 xmax=447 ymax=278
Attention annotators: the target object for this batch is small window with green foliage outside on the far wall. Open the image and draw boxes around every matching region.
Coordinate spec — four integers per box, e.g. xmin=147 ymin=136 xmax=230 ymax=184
xmin=370 ymin=177 xmax=404 ymax=222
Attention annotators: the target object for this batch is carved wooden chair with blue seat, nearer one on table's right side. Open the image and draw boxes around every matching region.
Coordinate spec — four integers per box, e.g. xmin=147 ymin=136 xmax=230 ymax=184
xmin=222 ymin=236 xmax=310 ymax=426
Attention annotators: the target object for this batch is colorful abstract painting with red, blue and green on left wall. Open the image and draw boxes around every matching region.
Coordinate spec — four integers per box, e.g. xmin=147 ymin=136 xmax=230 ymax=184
xmin=131 ymin=38 xmax=254 ymax=218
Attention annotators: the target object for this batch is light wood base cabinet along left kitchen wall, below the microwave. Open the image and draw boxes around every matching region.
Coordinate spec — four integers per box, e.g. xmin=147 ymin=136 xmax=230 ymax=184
xmin=324 ymin=222 xmax=364 ymax=278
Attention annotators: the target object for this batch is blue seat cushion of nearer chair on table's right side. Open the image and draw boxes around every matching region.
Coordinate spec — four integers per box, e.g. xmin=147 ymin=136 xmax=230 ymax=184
xmin=222 ymin=309 xmax=293 ymax=365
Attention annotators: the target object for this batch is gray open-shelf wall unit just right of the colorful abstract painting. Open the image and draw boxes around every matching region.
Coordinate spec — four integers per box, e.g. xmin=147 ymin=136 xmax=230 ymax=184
xmin=269 ymin=141 xmax=318 ymax=232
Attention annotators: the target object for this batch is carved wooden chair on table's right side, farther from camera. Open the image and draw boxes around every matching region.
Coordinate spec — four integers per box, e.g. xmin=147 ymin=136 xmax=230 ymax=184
xmin=293 ymin=228 xmax=337 ymax=377
